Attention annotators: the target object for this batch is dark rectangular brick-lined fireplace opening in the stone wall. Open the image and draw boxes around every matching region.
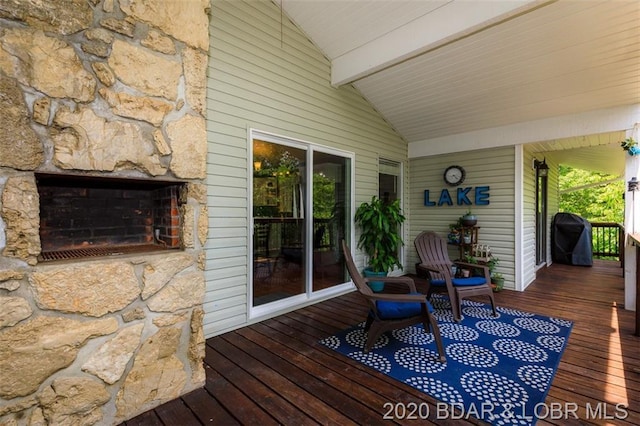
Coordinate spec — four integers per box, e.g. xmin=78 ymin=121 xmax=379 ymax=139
xmin=36 ymin=174 xmax=185 ymax=261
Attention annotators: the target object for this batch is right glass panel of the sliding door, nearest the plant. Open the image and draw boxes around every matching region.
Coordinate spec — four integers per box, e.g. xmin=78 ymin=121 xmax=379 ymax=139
xmin=312 ymin=151 xmax=351 ymax=291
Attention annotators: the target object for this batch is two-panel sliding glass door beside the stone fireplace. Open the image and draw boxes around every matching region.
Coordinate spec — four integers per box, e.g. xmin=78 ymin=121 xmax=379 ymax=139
xmin=252 ymin=138 xmax=351 ymax=307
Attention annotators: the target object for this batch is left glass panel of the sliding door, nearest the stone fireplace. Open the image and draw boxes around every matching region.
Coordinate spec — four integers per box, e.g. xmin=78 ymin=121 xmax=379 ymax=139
xmin=253 ymin=139 xmax=307 ymax=306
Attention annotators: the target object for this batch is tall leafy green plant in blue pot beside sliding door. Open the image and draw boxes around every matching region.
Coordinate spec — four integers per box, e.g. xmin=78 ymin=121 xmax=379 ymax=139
xmin=354 ymin=196 xmax=405 ymax=291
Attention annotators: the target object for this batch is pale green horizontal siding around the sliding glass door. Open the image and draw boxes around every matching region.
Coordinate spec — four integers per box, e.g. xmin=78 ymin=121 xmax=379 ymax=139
xmin=204 ymin=0 xmax=407 ymax=337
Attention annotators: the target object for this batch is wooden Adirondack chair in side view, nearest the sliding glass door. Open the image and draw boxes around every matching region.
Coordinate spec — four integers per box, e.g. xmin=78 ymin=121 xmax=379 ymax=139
xmin=342 ymin=240 xmax=446 ymax=362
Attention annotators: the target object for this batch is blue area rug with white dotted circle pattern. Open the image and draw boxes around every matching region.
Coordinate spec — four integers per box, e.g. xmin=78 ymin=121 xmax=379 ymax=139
xmin=321 ymin=295 xmax=573 ymax=425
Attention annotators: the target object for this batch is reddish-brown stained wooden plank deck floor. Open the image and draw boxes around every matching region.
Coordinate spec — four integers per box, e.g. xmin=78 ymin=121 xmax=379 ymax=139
xmin=126 ymin=262 xmax=640 ymax=426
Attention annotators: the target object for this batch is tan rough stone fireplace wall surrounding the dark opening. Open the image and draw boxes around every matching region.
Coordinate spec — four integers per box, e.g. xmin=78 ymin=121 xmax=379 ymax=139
xmin=0 ymin=0 xmax=209 ymax=425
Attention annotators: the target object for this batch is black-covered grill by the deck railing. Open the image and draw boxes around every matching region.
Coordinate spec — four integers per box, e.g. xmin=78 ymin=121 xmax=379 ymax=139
xmin=551 ymin=213 xmax=593 ymax=266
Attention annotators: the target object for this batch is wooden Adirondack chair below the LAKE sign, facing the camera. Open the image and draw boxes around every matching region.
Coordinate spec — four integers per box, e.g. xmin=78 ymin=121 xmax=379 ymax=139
xmin=414 ymin=231 xmax=496 ymax=322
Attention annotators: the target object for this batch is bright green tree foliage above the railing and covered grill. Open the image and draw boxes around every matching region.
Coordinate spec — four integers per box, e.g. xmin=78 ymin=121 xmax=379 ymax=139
xmin=559 ymin=165 xmax=625 ymax=223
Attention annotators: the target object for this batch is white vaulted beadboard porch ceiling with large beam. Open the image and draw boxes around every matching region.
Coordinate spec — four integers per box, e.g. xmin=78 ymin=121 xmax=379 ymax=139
xmin=282 ymin=0 xmax=640 ymax=174
